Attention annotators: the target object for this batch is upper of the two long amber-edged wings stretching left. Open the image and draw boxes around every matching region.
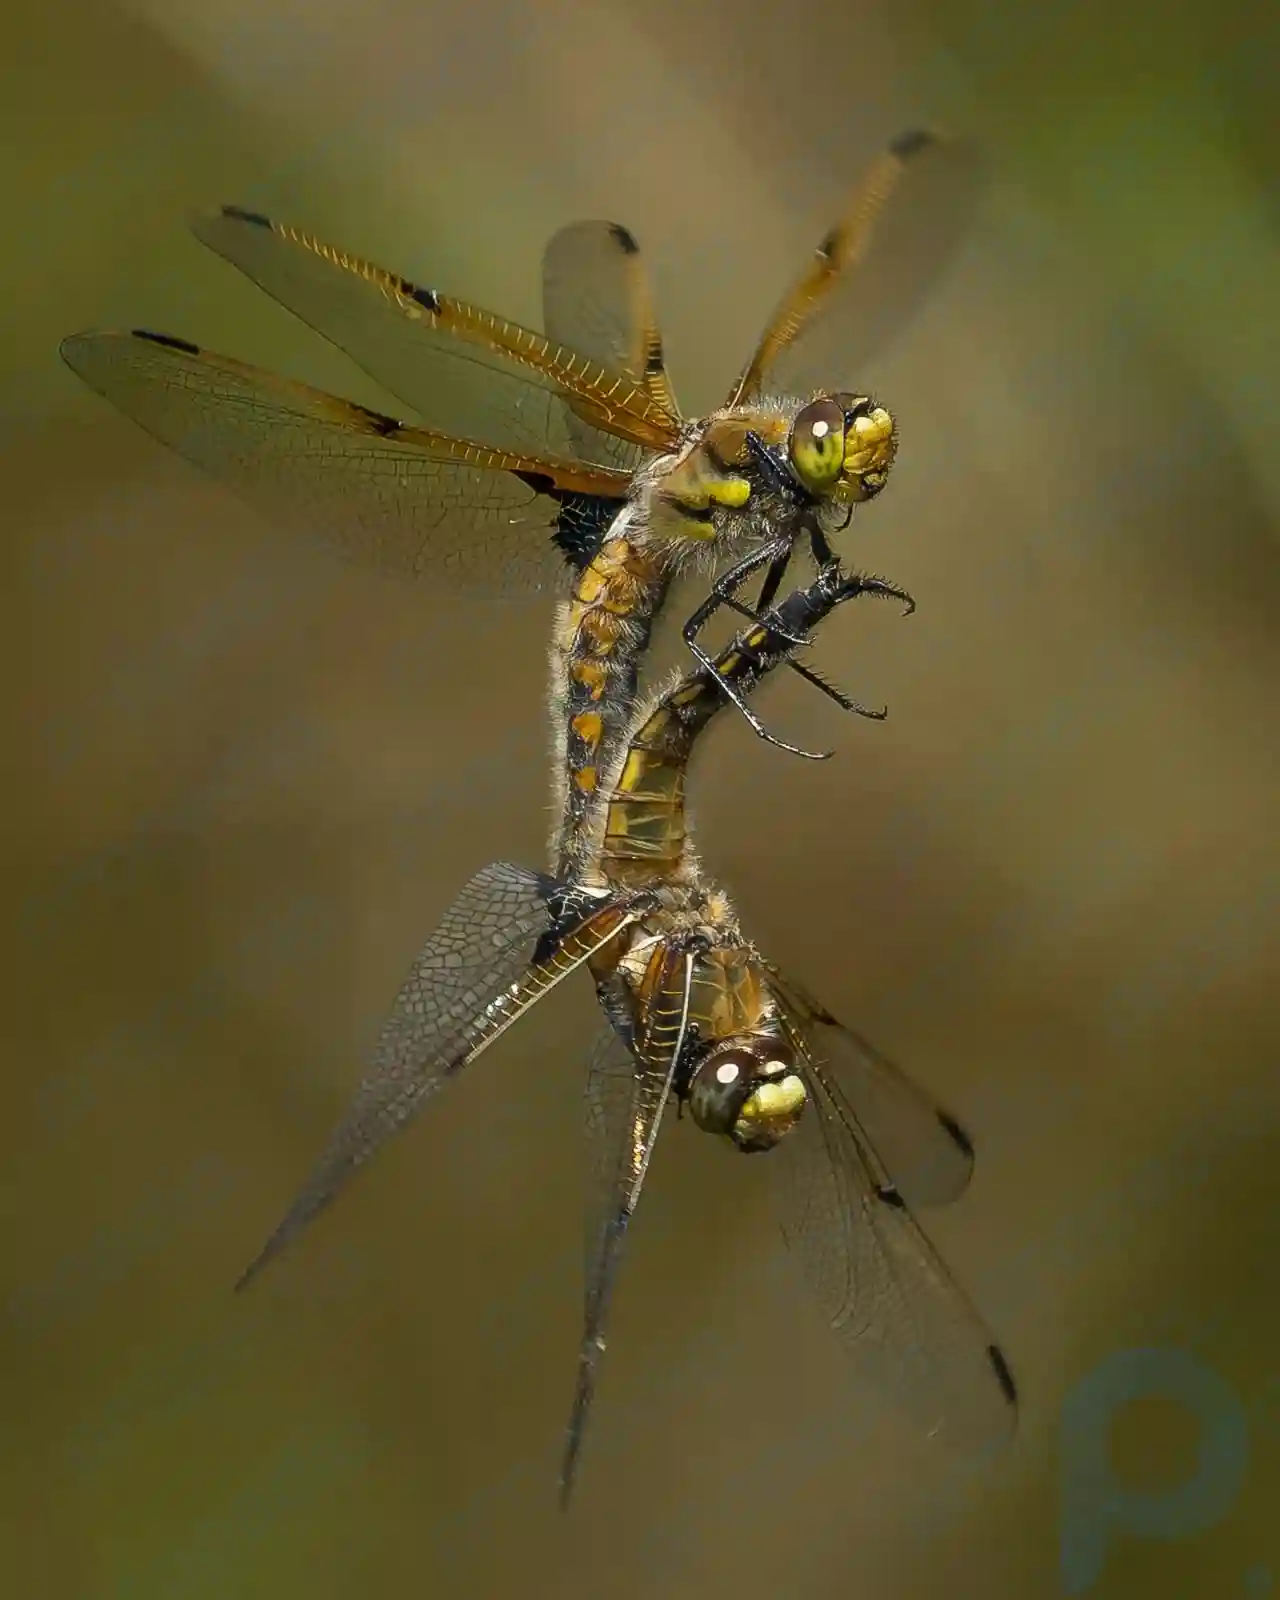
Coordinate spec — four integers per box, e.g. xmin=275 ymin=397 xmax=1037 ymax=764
xmin=192 ymin=206 xmax=675 ymax=466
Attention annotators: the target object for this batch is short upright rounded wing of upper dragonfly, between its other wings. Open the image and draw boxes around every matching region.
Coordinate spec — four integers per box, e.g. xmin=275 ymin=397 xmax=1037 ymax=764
xmin=542 ymin=222 xmax=678 ymax=470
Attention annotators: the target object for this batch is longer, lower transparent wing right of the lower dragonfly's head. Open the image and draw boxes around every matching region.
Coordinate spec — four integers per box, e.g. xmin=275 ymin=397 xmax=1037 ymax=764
xmin=774 ymin=972 xmax=1018 ymax=1453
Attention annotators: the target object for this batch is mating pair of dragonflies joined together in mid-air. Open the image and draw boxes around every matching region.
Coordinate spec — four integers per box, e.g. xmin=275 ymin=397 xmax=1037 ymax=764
xmin=62 ymin=124 xmax=1016 ymax=1498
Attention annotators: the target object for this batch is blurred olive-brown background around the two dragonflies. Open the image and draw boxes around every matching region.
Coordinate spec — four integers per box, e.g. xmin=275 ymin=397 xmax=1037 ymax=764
xmin=0 ymin=0 xmax=1280 ymax=1600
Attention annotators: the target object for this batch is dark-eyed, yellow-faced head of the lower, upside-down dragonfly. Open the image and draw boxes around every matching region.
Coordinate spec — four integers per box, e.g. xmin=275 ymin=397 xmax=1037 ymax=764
xmin=688 ymin=1034 xmax=808 ymax=1152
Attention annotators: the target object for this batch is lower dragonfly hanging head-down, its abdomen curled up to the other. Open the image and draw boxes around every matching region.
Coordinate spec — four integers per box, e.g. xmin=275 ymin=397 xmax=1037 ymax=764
xmin=240 ymin=562 xmax=1016 ymax=1504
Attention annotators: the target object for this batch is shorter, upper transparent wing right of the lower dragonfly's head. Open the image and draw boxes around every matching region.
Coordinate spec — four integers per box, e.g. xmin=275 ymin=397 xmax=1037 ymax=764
xmin=766 ymin=963 xmax=973 ymax=1206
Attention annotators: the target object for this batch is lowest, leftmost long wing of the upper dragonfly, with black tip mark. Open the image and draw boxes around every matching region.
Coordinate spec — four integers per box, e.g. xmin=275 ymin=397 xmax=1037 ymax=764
xmin=62 ymin=333 xmax=627 ymax=594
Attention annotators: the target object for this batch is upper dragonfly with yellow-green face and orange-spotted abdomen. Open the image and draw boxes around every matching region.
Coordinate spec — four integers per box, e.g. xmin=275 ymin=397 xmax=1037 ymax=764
xmin=61 ymin=131 xmax=982 ymax=878
